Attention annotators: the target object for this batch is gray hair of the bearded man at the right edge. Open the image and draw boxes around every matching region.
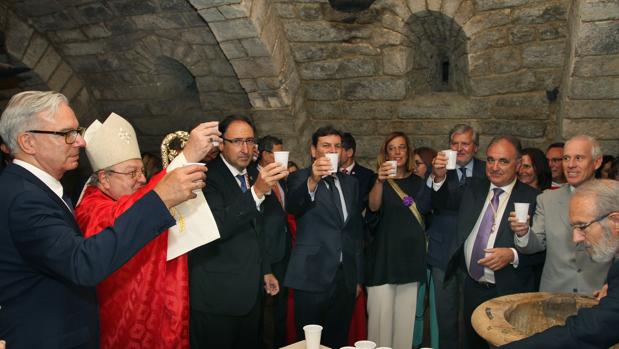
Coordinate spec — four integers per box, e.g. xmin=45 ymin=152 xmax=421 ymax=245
xmin=572 ymin=179 xmax=619 ymax=216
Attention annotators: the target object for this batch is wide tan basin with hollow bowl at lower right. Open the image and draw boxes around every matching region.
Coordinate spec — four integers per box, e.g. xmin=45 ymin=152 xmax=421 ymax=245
xmin=471 ymin=292 xmax=619 ymax=348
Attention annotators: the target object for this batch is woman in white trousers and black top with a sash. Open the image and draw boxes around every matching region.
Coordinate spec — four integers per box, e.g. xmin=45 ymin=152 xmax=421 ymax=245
xmin=366 ymin=132 xmax=429 ymax=348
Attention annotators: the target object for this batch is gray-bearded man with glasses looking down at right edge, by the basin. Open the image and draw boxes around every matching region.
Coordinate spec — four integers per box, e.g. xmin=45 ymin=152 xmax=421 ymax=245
xmin=501 ymin=180 xmax=619 ymax=349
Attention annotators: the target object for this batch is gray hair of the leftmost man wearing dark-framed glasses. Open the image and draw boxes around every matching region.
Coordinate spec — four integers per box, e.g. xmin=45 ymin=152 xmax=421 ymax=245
xmin=0 ymin=91 xmax=69 ymax=155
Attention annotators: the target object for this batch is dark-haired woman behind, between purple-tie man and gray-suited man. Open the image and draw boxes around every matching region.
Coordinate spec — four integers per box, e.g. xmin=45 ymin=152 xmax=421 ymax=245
xmin=518 ymin=148 xmax=552 ymax=191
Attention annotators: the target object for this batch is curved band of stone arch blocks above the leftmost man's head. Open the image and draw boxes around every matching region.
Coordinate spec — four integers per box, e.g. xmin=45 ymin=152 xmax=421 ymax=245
xmin=0 ymin=6 xmax=96 ymax=120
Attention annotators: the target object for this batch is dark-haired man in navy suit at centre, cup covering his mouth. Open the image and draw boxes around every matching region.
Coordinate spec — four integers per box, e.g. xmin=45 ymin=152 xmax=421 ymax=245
xmin=284 ymin=126 xmax=368 ymax=348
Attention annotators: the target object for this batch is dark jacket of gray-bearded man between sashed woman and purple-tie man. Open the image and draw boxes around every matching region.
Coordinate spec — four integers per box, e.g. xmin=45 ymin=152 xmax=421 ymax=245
xmin=427 ymin=158 xmax=486 ymax=270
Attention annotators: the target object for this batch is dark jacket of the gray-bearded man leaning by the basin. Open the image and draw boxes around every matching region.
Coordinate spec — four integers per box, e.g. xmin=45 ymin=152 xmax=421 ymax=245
xmin=501 ymin=262 xmax=619 ymax=349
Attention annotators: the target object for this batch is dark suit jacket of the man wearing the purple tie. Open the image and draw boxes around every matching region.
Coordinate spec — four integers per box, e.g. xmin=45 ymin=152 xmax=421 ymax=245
xmin=445 ymin=178 xmax=539 ymax=296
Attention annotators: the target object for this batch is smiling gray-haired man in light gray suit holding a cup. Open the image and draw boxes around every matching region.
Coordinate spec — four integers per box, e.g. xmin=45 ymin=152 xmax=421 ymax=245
xmin=510 ymin=135 xmax=612 ymax=295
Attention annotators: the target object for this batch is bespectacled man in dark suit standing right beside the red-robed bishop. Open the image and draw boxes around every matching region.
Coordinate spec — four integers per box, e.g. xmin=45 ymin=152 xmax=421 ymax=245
xmin=189 ymin=115 xmax=288 ymax=349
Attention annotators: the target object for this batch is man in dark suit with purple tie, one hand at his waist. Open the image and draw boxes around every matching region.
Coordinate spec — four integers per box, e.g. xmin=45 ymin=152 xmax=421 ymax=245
xmin=444 ymin=136 xmax=538 ymax=349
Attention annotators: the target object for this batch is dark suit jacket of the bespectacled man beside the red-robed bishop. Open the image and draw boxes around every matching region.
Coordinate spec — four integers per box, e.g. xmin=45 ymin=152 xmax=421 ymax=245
xmin=189 ymin=155 xmax=268 ymax=316
